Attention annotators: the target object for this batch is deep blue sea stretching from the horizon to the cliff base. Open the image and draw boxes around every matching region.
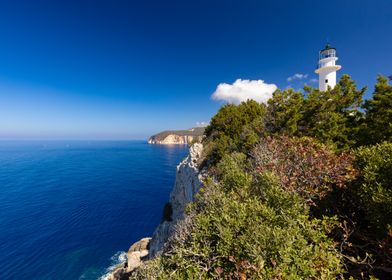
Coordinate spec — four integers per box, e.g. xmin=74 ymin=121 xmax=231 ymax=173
xmin=0 ymin=141 xmax=187 ymax=280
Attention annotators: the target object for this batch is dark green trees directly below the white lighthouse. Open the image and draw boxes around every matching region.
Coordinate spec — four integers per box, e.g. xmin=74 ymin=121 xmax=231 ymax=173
xmin=265 ymin=75 xmax=366 ymax=150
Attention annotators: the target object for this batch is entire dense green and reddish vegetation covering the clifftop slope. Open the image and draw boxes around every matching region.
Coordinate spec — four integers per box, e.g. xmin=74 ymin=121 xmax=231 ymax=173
xmin=132 ymin=75 xmax=392 ymax=279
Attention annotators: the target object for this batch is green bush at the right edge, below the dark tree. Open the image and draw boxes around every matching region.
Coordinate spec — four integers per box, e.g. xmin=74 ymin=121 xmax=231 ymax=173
xmin=355 ymin=142 xmax=392 ymax=236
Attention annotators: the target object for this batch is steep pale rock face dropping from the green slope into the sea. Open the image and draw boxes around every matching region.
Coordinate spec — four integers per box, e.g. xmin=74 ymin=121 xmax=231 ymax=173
xmin=107 ymin=143 xmax=203 ymax=280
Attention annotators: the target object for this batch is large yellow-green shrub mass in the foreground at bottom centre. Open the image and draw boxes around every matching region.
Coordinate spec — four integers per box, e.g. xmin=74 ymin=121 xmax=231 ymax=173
xmin=133 ymin=154 xmax=342 ymax=279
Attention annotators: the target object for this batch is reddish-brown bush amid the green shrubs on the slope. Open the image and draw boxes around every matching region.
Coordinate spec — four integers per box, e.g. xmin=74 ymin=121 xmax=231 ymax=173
xmin=252 ymin=136 xmax=354 ymax=202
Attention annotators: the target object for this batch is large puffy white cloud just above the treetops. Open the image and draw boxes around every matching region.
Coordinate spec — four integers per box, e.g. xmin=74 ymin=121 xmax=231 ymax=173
xmin=212 ymin=79 xmax=278 ymax=104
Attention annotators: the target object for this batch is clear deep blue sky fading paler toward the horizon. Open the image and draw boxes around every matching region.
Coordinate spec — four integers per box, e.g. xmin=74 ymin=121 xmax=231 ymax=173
xmin=0 ymin=0 xmax=392 ymax=139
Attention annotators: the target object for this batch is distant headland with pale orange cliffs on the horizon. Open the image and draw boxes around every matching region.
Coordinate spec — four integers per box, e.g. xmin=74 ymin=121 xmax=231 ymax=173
xmin=148 ymin=127 xmax=204 ymax=145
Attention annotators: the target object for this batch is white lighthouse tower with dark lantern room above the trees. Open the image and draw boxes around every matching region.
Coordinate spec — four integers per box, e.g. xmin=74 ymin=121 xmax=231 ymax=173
xmin=315 ymin=44 xmax=342 ymax=91
